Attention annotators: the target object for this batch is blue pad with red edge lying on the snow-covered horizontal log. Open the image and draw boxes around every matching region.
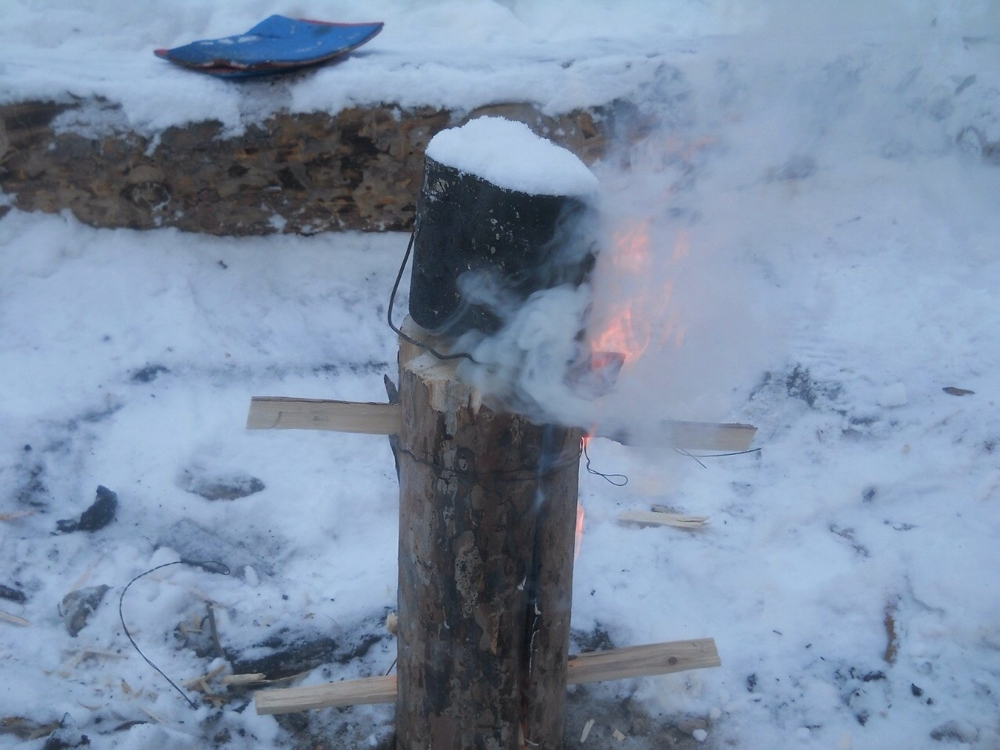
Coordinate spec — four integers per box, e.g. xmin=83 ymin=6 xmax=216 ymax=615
xmin=154 ymin=16 xmax=384 ymax=78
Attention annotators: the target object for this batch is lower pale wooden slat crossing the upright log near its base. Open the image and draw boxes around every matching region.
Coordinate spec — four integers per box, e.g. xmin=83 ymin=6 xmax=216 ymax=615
xmin=254 ymin=638 xmax=722 ymax=714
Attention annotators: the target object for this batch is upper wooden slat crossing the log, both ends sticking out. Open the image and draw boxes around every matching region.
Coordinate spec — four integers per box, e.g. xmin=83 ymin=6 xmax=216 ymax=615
xmin=247 ymin=396 xmax=757 ymax=451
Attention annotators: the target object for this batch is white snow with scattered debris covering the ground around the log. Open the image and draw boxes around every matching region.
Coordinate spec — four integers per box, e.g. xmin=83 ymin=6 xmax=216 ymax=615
xmin=0 ymin=0 xmax=1000 ymax=750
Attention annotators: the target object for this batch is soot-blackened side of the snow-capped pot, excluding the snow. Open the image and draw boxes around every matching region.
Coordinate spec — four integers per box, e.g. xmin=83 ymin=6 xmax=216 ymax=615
xmin=410 ymin=157 xmax=596 ymax=336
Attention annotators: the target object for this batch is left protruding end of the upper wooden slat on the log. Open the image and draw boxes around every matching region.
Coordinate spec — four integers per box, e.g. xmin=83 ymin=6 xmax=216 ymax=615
xmin=247 ymin=396 xmax=401 ymax=435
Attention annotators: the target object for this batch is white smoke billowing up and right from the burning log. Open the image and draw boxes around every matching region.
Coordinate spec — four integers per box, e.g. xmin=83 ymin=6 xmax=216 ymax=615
xmin=456 ymin=0 xmax=1000 ymax=442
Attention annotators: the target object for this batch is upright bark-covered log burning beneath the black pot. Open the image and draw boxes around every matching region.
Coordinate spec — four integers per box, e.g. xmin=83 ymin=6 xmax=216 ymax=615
xmin=396 ymin=334 xmax=580 ymax=750
